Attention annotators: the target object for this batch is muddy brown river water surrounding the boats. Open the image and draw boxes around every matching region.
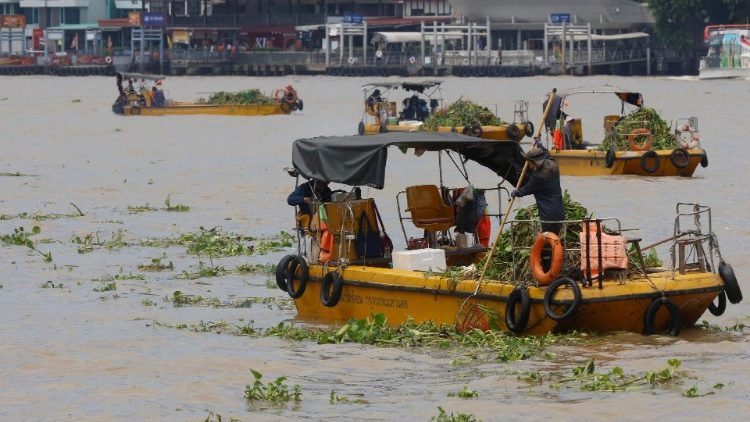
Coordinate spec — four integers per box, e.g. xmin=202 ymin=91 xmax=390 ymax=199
xmin=0 ymin=76 xmax=750 ymax=421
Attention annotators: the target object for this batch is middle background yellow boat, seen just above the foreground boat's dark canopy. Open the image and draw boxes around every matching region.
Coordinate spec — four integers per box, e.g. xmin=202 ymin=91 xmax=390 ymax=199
xmin=357 ymin=80 xmax=534 ymax=141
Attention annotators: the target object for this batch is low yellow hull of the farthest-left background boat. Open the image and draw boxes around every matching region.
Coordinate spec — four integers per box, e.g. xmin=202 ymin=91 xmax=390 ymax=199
xmin=123 ymin=103 xmax=289 ymax=116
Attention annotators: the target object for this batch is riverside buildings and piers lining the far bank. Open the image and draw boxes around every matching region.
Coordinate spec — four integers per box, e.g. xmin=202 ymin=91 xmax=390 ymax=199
xmin=0 ymin=0 xmax=684 ymax=77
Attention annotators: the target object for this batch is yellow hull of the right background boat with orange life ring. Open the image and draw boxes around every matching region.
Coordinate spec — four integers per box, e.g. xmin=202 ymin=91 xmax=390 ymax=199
xmin=550 ymin=148 xmax=706 ymax=177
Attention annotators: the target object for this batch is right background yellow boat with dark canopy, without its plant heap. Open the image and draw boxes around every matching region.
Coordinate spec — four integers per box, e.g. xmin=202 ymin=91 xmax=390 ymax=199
xmin=545 ymin=85 xmax=708 ymax=177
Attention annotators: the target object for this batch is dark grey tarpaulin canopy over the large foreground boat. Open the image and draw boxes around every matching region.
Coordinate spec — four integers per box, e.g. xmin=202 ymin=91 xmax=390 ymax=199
xmin=292 ymin=132 xmax=524 ymax=189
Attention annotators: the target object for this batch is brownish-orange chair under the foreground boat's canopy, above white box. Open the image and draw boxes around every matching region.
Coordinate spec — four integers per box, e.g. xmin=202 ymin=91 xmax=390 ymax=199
xmin=406 ymin=185 xmax=455 ymax=233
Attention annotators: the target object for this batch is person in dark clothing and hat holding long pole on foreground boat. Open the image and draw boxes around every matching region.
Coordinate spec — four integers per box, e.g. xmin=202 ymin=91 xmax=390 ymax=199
xmin=511 ymin=148 xmax=565 ymax=234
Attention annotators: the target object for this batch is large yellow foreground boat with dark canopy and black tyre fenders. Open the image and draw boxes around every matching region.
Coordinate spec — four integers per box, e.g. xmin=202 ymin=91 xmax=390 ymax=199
xmin=276 ymin=132 xmax=742 ymax=335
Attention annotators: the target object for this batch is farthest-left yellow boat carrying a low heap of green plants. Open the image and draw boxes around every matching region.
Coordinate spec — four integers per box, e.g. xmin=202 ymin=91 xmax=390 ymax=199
xmin=112 ymin=73 xmax=304 ymax=116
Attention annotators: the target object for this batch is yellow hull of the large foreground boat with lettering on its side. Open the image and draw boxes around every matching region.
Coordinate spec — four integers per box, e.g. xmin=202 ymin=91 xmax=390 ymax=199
xmin=295 ymin=265 xmax=723 ymax=334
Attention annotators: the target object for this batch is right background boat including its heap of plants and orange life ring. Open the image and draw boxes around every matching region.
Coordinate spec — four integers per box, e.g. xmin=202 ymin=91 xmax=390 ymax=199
xmin=545 ymin=85 xmax=708 ymax=177
